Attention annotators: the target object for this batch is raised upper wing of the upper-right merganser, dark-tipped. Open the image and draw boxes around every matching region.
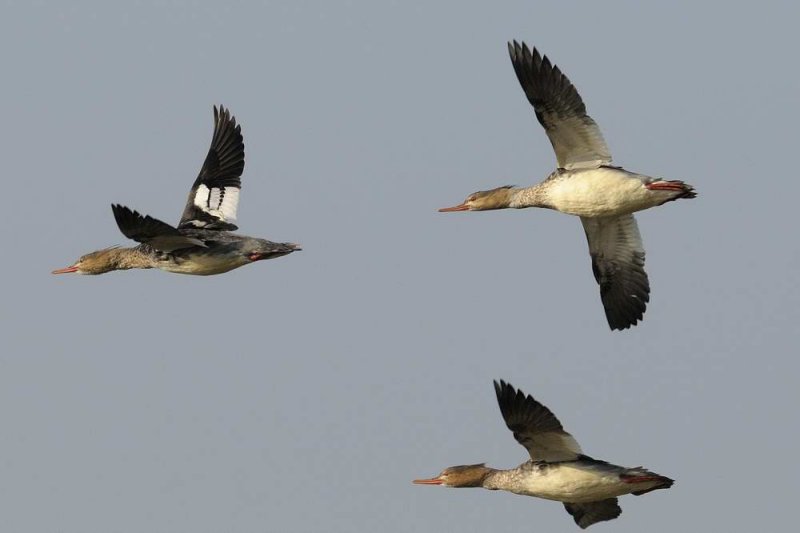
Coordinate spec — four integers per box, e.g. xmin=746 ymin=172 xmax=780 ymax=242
xmin=508 ymin=41 xmax=611 ymax=169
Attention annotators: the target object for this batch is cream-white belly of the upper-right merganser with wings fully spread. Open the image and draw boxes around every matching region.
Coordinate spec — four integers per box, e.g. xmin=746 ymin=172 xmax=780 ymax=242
xmin=547 ymin=168 xmax=674 ymax=217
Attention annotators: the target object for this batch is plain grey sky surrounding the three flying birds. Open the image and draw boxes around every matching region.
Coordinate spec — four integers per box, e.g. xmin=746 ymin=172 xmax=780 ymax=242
xmin=0 ymin=1 xmax=800 ymax=533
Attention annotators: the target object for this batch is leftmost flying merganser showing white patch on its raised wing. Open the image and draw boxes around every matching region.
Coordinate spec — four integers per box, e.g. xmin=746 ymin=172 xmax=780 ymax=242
xmin=53 ymin=106 xmax=300 ymax=276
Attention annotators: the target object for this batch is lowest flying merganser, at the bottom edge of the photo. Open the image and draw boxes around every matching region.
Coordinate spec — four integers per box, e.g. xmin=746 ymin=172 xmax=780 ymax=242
xmin=414 ymin=380 xmax=673 ymax=529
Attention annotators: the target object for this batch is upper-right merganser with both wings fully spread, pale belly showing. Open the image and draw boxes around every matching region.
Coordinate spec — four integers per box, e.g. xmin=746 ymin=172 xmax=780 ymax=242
xmin=439 ymin=41 xmax=695 ymax=330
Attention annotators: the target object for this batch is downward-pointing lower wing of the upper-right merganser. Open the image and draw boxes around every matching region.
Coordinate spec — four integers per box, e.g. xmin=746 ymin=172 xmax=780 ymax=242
xmin=581 ymin=215 xmax=650 ymax=330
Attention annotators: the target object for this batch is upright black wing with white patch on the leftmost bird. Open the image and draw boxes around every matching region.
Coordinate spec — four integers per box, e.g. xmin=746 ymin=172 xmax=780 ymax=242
xmin=178 ymin=106 xmax=244 ymax=230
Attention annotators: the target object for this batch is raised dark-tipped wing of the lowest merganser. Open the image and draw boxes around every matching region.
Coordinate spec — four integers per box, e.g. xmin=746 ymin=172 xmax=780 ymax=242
xmin=494 ymin=380 xmax=581 ymax=462
